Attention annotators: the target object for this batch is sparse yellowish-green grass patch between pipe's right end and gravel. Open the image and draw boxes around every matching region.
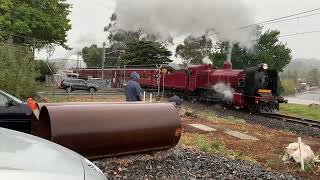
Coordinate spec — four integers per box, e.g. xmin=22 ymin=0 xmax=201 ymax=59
xmin=180 ymin=133 xmax=256 ymax=162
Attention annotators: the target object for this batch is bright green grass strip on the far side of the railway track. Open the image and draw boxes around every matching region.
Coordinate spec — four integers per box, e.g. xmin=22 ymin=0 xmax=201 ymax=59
xmin=280 ymin=104 xmax=320 ymax=121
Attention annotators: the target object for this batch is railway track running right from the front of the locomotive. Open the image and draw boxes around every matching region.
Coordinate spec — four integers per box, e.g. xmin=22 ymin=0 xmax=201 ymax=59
xmin=261 ymin=114 xmax=320 ymax=128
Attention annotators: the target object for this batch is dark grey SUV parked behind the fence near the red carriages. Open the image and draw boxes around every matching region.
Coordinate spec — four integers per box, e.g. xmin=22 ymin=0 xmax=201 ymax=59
xmin=60 ymin=79 xmax=98 ymax=93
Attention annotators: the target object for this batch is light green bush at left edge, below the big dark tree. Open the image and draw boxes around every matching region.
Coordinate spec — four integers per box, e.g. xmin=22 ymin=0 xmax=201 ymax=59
xmin=0 ymin=43 xmax=38 ymax=98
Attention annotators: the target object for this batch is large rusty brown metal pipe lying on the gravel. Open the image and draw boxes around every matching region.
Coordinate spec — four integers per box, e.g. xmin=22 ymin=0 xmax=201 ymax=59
xmin=32 ymin=103 xmax=181 ymax=158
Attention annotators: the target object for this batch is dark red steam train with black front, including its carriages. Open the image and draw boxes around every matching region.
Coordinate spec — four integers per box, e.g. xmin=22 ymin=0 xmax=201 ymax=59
xmin=79 ymin=61 xmax=285 ymax=114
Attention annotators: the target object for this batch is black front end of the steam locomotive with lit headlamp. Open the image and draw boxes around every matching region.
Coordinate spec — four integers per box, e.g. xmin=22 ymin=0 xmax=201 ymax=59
xmin=244 ymin=64 xmax=284 ymax=114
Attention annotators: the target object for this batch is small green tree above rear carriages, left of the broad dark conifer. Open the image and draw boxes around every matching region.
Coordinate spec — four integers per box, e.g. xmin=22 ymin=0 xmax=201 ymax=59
xmin=82 ymin=44 xmax=102 ymax=67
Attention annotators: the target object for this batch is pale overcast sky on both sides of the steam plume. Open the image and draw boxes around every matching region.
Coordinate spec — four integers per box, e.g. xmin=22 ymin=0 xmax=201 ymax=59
xmin=38 ymin=0 xmax=320 ymax=59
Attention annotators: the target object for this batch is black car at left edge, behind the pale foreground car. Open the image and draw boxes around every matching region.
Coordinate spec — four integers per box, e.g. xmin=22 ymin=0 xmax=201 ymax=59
xmin=0 ymin=94 xmax=31 ymax=133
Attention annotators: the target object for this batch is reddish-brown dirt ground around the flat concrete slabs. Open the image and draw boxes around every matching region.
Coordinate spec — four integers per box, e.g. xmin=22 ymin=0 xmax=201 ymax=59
xmin=182 ymin=114 xmax=320 ymax=179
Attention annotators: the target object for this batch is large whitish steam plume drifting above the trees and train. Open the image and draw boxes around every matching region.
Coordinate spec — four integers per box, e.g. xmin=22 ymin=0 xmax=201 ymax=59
xmin=115 ymin=0 xmax=254 ymax=45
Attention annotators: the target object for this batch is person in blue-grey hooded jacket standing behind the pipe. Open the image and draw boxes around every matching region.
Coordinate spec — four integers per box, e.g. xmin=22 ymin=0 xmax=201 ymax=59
xmin=125 ymin=72 xmax=142 ymax=102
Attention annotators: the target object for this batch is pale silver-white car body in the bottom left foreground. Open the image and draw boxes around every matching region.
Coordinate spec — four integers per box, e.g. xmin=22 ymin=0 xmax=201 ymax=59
xmin=0 ymin=128 xmax=107 ymax=180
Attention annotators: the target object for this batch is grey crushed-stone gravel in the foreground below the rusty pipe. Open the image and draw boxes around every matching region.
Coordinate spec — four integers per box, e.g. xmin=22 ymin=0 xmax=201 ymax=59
xmin=95 ymin=148 xmax=299 ymax=179
